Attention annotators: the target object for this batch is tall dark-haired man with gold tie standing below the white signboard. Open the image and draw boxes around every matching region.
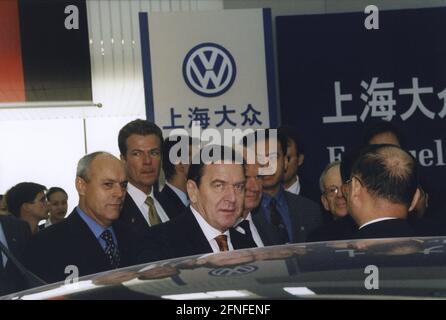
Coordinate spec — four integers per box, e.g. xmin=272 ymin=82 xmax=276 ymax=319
xmin=116 ymin=119 xmax=170 ymax=243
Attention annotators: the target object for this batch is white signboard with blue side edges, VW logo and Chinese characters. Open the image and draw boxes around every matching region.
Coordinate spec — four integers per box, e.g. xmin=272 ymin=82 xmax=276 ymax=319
xmin=140 ymin=9 xmax=277 ymax=134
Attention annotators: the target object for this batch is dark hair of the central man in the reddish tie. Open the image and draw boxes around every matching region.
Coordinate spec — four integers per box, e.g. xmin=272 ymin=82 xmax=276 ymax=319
xmin=187 ymin=145 xmax=244 ymax=187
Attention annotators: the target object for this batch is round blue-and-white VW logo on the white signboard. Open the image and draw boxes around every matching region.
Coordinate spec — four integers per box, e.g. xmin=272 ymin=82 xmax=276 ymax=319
xmin=183 ymin=42 xmax=237 ymax=97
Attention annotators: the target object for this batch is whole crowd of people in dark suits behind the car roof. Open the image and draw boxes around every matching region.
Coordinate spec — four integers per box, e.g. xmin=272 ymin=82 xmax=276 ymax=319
xmin=0 ymin=119 xmax=443 ymax=295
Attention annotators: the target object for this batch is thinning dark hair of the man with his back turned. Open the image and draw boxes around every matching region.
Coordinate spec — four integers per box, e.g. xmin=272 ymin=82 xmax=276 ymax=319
xmin=351 ymin=144 xmax=419 ymax=207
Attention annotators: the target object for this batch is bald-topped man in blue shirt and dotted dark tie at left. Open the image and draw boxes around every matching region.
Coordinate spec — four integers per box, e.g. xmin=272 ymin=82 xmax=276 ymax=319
xmin=25 ymin=152 xmax=132 ymax=282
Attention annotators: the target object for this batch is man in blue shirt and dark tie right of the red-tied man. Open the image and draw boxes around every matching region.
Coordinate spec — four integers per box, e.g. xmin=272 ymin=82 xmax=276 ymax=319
xmin=249 ymin=129 xmax=322 ymax=245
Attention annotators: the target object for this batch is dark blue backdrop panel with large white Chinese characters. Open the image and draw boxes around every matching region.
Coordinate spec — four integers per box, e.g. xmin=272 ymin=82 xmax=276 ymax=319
xmin=276 ymin=8 xmax=446 ymax=208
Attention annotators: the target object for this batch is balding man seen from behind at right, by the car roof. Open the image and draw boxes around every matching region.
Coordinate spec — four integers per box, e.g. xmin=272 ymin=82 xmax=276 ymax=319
xmin=343 ymin=145 xmax=420 ymax=239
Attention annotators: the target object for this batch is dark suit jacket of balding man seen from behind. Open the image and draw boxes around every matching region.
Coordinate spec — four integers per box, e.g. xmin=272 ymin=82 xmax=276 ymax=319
xmin=354 ymin=219 xmax=417 ymax=239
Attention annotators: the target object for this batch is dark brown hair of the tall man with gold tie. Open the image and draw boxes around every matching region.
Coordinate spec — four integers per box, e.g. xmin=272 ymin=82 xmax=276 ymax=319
xmin=118 ymin=119 xmax=163 ymax=157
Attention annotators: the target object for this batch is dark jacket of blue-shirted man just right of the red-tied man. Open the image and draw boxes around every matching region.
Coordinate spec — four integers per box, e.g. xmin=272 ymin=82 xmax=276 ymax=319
xmin=252 ymin=191 xmax=322 ymax=246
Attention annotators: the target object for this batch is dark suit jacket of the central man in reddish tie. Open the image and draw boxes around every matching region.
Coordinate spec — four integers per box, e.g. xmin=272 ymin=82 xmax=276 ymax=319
xmin=138 ymin=208 xmax=254 ymax=263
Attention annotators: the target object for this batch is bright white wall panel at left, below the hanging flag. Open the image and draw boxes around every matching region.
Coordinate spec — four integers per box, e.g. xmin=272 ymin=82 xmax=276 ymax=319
xmin=0 ymin=119 xmax=85 ymax=214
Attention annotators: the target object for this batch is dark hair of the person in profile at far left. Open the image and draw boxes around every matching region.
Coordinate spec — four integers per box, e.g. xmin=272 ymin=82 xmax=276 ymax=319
xmin=6 ymin=182 xmax=46 ymax=218
